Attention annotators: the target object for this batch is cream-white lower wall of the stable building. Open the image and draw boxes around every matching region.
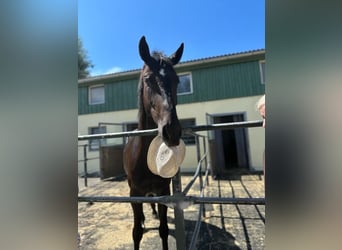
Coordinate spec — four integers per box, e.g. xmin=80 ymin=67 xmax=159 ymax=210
xmin=78 ymin=96 xmax=265 ymax=176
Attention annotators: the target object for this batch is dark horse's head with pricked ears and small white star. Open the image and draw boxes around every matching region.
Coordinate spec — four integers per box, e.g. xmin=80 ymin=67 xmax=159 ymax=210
xmin=139 ymin=36 xmax=184 ymax=147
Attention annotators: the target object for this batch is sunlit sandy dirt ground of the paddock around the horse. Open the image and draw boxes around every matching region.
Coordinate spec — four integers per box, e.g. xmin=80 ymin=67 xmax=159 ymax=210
xmin=78 ymin=175 xmax=265 ymax=250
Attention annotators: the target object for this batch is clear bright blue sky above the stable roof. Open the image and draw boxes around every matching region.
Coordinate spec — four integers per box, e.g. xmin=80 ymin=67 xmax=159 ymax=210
xmin=78 ymin=0 xmax=265 ymax=76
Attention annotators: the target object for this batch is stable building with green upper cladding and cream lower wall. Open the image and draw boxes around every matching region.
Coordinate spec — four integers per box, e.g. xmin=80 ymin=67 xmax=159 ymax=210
xmin=78 ymin=49 xmax=265 ymax=178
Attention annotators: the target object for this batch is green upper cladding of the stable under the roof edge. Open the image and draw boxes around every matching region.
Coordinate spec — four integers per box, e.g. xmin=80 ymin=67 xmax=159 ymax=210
xmin=78 ymin=50 xmax=265 ymax=114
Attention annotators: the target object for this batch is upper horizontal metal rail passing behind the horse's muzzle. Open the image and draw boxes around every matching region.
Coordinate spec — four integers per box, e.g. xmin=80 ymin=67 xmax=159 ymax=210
xmin=78 ymin=121 xmax=262 ymax=141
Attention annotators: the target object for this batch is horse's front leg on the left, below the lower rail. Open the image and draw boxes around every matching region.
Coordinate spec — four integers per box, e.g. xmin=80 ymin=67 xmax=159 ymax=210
xmin=131 ymin=203 xmax=145 ymax=250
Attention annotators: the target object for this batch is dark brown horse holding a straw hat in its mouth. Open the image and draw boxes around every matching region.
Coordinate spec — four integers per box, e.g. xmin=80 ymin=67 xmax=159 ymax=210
xmin=124 ymin=36 xmax=184 ymax=250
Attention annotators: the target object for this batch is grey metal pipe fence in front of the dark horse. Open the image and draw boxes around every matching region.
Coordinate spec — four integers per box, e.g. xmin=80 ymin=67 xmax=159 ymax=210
xmin=78 ymin=121 xmax=265 ymax=250
